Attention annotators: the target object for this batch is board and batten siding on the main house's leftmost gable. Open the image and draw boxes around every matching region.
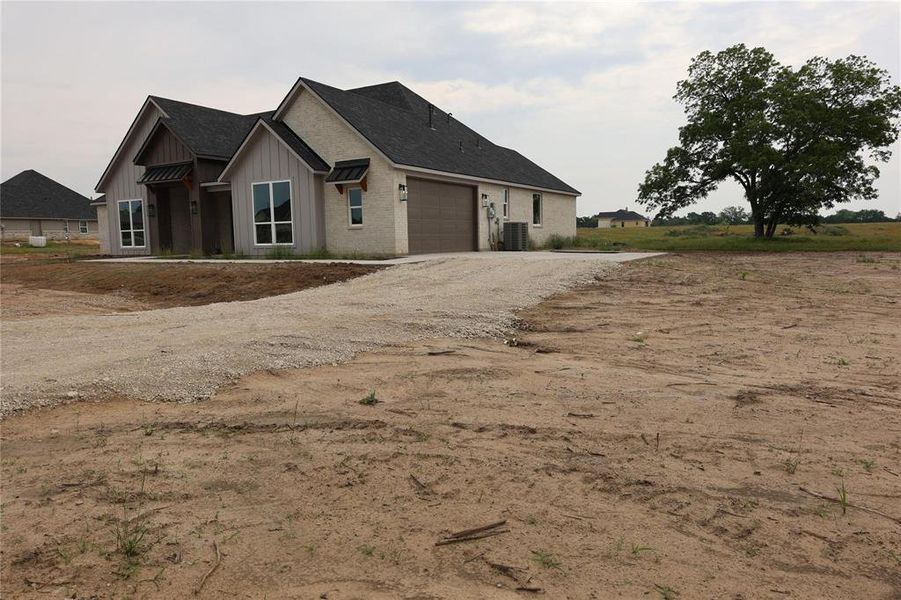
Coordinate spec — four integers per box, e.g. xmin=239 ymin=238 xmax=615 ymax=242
xmin=97 ymin=104 xmax=161 ymax=255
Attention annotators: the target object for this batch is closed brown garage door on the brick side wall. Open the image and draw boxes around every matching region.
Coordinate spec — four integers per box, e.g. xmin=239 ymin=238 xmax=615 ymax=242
xmin=407 ymin=179 xmax=476 ymax=254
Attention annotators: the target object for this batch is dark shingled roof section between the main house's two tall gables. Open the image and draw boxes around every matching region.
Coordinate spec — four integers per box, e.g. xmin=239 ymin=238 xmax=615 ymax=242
xmin=150 ymin=96 xmax=272 ymax=160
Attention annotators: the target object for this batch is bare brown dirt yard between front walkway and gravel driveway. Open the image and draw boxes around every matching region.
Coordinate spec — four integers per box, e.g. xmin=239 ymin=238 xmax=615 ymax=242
xmin=0 ymin=261 xmax=380 ymax=320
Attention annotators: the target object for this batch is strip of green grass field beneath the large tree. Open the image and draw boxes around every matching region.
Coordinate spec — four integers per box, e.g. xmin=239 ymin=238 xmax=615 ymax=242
xmin=578 ymin=222 xmax=901 ymax=252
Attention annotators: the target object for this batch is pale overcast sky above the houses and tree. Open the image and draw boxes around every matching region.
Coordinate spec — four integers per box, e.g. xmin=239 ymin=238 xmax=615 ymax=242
xmin=0 ymin=2 xmax=901 ymax=215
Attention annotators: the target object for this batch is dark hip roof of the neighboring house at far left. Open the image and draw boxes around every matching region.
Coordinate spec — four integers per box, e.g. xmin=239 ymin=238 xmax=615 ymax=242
xmin=0 ymin=169 xmax=97 ymax=221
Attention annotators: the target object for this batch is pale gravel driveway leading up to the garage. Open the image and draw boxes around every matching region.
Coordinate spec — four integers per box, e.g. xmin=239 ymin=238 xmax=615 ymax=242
xmin=0 ymin=253 xmax=640 ymax=415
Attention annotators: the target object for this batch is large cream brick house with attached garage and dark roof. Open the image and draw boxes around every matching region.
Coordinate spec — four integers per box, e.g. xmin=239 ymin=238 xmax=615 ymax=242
xmin=96 ymin=78 xmax=579 ymax=255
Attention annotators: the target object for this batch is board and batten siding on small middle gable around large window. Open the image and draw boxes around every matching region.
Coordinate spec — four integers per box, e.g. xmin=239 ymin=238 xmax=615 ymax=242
xmin=227 ymin=127 xmax=325 ymax=255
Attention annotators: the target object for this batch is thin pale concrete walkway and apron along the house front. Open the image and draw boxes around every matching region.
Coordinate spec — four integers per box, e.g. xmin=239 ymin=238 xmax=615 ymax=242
xmin=93 ymin=251 xmax=664 ymax=266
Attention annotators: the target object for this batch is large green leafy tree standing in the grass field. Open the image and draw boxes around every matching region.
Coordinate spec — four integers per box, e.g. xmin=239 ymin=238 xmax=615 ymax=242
xmin=638 ymin=44 xmax=901 ymax=238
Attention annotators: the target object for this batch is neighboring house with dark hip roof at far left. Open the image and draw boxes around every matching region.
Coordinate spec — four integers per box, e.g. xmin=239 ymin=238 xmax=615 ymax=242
xmin=0 ymin=169 xmax=97 ymax=240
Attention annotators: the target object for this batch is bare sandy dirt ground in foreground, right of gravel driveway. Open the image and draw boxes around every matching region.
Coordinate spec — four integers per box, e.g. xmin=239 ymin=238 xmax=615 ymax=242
xmin=0 ymin=254 xmax=901 ymax=600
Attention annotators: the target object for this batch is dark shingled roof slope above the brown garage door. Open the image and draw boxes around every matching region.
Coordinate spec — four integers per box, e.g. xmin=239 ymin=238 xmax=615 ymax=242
xmin=301 ymin=77 xmax=579 ymax=194
